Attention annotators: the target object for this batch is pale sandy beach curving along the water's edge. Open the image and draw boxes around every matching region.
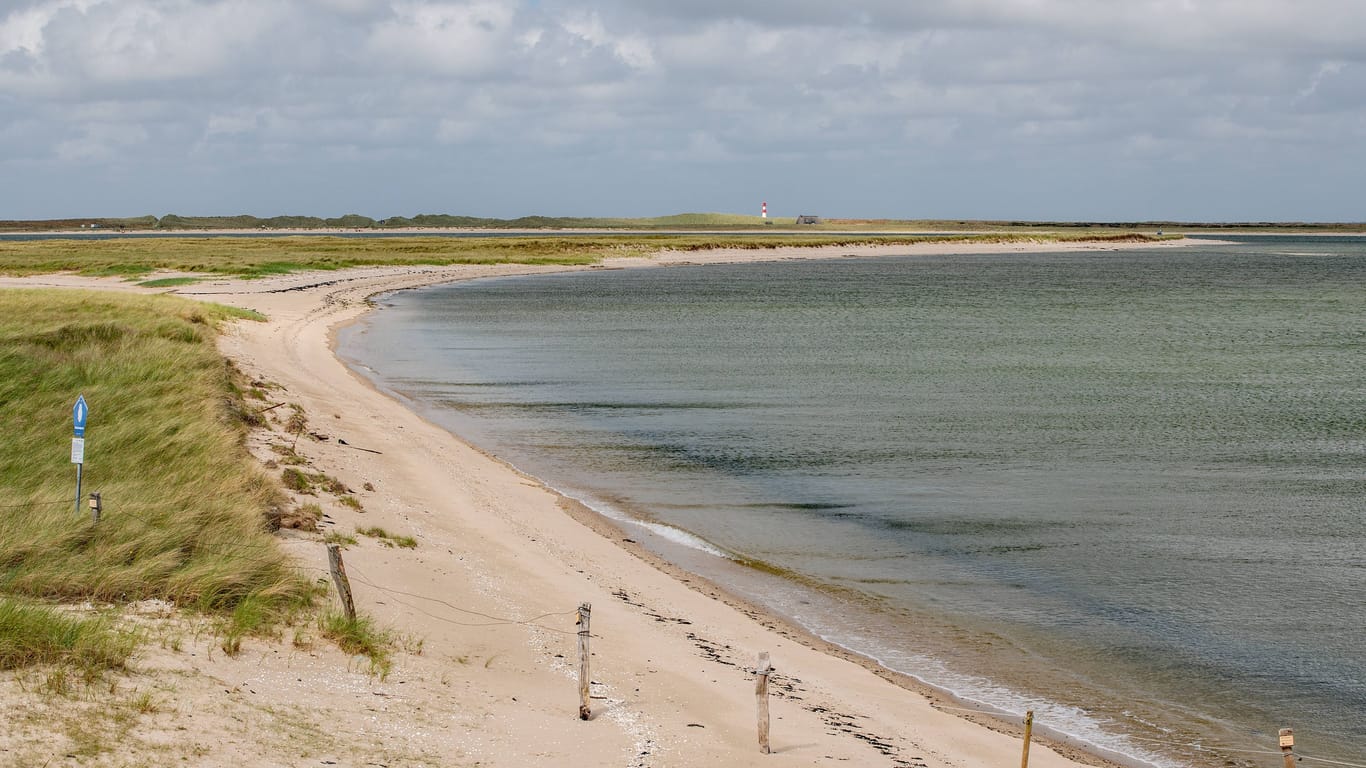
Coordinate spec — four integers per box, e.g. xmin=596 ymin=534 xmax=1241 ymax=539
xmin=0 ymin=241 xmax=1196 ymax=768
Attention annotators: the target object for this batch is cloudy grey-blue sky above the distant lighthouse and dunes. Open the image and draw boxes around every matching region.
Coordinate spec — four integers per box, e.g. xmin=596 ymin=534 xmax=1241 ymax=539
xmin=0 ymin=0 xmax=1366 ymax=221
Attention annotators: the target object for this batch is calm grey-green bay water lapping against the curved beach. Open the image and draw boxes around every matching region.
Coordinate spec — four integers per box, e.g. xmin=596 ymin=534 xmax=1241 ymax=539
xmin=342 ymin=238 xmax=1366 ymax=765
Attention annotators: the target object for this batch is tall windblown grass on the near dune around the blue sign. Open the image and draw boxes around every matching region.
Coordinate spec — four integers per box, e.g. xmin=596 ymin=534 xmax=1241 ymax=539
xmin=0 ymin=290 xmax=310 ymax=666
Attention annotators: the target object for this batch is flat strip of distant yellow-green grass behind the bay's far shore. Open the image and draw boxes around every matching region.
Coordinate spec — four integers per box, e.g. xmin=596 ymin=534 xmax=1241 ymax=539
xmin=0 ymin=232 xmax=1174 ymax=277
